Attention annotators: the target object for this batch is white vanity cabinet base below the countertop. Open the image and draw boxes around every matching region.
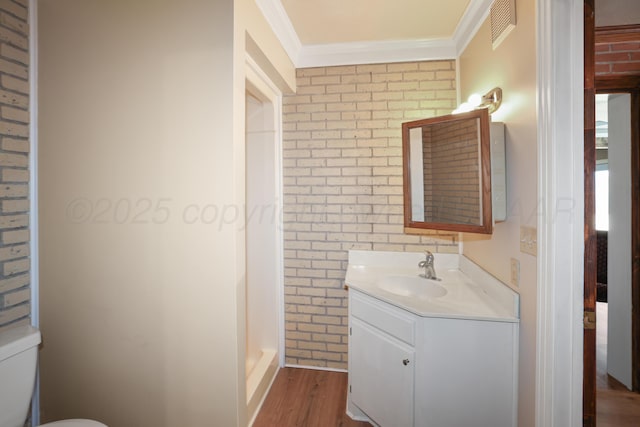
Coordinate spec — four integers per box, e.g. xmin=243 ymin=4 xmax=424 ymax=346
xmin=348 ymin=288 xmax=518 ymax=427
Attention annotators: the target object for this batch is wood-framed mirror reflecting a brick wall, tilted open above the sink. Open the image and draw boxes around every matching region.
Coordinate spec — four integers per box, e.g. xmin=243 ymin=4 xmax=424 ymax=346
xmin=402 ymin=109 xmax=493 ymax=234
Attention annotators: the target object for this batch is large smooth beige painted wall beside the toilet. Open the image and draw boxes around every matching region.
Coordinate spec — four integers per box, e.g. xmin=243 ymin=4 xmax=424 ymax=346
xmin=38 ymin=0 xmax=293 ymax=427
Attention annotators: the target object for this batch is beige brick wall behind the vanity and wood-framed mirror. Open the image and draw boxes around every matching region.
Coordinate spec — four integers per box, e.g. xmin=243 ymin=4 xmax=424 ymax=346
xmin=283 ymin=61 xmax=458 ymax=369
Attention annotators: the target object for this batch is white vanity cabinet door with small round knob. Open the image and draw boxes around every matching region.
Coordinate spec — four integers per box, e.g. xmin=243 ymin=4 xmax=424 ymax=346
xmin=349 ymin=318 xmax=415 ymax=427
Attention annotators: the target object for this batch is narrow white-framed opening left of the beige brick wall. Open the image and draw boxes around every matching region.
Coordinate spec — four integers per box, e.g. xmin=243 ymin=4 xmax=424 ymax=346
xmin=245 ymin=58 xmax=284 ymax=422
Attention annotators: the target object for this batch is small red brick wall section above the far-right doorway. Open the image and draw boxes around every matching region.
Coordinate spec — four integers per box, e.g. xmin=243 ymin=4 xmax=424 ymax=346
xmin=596 ymin=41 xmax=640 ymax=76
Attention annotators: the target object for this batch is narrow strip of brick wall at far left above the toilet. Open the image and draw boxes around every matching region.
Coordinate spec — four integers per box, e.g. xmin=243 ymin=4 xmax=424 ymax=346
xmin=0 ymin=0 xmax=31 ymax=329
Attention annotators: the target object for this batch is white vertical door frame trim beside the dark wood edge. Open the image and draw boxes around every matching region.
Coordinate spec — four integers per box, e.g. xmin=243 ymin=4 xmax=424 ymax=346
xmin=536 ymin=0 xmax=584 ymax=427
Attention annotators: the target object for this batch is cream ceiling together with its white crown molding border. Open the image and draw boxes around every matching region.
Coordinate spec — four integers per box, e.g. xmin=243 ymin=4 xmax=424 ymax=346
xmin=255 ymin=0 xmax=493 ymax=68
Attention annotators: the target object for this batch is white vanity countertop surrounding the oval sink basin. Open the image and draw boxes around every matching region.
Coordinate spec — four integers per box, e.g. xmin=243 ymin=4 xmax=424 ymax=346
xmin=345 ymin=251 xmax=520 ymax=322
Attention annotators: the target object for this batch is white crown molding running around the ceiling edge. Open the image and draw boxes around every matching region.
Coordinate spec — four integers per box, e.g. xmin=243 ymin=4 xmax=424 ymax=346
xmin=256 ymin=0 xmax=493 ymax=68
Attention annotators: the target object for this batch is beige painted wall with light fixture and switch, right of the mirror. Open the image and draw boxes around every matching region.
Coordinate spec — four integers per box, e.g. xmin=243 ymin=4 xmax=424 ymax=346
xmin=460 ymin=0 xmax=538 ymax=427
